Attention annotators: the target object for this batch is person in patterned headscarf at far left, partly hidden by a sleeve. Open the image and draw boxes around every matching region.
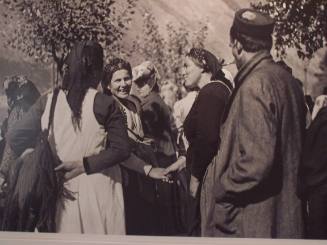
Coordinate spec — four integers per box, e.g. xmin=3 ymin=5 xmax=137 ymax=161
xmin=0 ymin=75 xmax=40 ymax=181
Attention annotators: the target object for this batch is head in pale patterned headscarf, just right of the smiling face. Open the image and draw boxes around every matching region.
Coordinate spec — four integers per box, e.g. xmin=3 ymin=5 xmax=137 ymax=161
xmin=131 ymin=61 xmax=160 ymax=98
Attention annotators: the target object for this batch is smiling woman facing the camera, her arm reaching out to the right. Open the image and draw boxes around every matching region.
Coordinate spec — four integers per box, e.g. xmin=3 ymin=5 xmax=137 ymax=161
xmin=102 ymin=58 xmax=167 ymax=235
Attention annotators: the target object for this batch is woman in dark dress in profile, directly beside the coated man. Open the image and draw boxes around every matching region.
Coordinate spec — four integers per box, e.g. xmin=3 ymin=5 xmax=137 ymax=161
xmin=167 ymin=48 xmax=233 ymax=236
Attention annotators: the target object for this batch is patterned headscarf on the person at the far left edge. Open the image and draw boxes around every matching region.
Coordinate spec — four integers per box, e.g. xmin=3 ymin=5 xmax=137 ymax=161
xmin=3 ymin=75 xmax=40 ymax=111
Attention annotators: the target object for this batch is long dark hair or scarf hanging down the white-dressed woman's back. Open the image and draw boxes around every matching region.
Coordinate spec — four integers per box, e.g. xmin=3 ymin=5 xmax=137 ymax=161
xmin=62 ymin=41 xmax=103 ymax=128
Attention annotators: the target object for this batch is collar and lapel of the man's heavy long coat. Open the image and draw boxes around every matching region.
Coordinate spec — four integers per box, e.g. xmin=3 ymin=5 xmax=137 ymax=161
xmin=222 ymin=50 xmax=272 ymax=123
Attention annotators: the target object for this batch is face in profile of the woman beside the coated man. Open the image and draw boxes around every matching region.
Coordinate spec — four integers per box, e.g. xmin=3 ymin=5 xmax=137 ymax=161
xmin=183 ymin=56 xmax=203 ymax=88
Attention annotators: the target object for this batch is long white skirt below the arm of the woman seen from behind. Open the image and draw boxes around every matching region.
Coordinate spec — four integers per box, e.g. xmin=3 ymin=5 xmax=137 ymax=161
xmin=56 ymin=165 xmax=126 ymax=235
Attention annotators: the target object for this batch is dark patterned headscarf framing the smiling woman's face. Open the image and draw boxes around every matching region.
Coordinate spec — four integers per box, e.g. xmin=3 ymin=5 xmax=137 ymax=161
xmin=101 ymin=58 xmax=133 ymax=90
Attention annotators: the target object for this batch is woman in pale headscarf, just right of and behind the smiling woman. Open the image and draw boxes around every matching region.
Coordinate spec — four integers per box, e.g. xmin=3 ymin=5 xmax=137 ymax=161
xmin=131 ymin=61 xmax=182 ymax=235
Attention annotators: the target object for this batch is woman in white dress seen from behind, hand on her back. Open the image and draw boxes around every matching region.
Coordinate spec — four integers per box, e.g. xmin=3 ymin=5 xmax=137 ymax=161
xmin=5 ymin=41 xmax=130 ymax=234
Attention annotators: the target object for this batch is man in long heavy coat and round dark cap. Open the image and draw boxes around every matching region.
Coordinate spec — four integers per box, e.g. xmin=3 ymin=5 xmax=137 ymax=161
xmin=201 ymin=9 xmax=305 ymax=238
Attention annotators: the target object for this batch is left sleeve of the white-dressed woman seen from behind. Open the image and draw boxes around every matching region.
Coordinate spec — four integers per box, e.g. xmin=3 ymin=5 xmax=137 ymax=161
xmin=7 ymin=95 xmax=47 ymax=156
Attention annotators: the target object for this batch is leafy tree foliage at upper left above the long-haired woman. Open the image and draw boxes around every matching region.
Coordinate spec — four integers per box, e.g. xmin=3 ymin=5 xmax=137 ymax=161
xmin=1 ymin=0 xmax=136 ymax=78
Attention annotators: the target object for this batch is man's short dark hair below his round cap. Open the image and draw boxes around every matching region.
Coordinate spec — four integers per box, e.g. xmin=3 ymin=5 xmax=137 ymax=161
xmin=229 ymin=27 xmax=273 ymax=53
